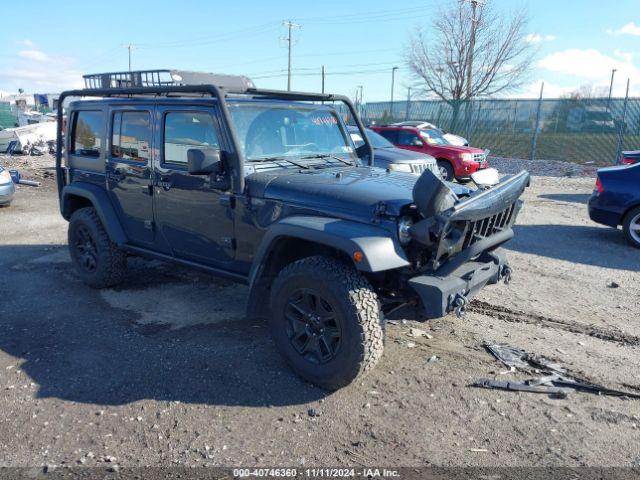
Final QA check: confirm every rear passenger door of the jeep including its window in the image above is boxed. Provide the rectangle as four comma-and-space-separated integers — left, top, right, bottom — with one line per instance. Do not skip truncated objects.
106, 106, 154, 246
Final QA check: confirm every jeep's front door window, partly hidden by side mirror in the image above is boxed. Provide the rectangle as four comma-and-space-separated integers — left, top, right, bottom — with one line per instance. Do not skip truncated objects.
164, 112, 220, 165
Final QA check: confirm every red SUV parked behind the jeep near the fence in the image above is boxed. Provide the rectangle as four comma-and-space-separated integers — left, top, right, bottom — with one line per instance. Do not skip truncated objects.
371, 126, 489, 181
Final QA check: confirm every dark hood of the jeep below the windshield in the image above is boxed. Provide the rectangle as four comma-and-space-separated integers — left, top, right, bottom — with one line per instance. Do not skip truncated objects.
246, 166, 471, 222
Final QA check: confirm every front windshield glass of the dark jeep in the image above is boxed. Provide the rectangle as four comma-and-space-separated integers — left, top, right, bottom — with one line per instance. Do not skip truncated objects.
229, 102, 357, 161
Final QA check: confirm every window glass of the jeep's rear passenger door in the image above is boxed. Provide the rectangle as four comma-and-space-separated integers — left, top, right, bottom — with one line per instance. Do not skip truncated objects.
111, 112, 151, 162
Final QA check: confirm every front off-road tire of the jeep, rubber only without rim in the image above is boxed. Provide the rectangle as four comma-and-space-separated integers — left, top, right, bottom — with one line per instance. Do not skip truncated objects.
270, 256, 384, 390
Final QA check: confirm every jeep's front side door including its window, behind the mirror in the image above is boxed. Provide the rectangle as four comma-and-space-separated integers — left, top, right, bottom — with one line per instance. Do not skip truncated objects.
154, 106, 235, 266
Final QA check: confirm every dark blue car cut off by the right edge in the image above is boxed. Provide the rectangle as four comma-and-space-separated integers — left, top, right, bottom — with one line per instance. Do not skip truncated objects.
589, 163, 640, 248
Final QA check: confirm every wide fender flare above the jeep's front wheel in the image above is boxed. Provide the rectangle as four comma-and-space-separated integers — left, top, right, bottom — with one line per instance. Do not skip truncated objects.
249, 215, 410, 285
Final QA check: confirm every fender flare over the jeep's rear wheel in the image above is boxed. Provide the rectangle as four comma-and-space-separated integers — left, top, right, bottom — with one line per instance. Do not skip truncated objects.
60, 182, 127, 246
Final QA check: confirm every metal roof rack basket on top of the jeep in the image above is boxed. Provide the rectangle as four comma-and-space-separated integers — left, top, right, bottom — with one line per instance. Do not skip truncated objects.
82, 69, 255, 90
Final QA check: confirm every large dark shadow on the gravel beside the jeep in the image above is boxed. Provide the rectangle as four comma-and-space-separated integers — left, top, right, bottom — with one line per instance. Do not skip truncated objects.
0, 245, 327, 407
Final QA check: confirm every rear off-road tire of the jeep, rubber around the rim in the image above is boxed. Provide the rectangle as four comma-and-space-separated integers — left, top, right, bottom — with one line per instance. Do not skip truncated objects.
68, 207, 127, 288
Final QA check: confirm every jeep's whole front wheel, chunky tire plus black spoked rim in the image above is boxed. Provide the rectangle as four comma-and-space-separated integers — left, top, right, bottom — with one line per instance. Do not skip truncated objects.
271, 257, 383, 390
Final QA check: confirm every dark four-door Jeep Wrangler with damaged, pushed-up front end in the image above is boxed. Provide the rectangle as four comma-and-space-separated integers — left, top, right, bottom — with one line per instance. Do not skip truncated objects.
56, 70, 529, 389
